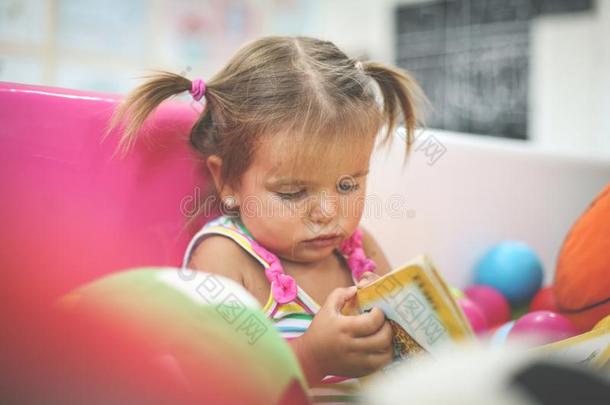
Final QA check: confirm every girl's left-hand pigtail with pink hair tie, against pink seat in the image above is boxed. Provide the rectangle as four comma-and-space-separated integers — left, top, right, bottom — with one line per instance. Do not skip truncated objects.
103, 71, 192, 157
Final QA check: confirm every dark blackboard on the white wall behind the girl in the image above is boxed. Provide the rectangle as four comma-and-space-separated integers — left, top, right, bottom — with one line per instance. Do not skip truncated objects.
395, 0, 592, 139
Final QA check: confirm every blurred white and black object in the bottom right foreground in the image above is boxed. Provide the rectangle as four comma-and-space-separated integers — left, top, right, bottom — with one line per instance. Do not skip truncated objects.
366, 346, 610, 405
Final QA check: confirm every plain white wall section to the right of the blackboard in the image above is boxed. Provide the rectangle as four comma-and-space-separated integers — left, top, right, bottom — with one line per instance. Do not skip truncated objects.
530, 1, 610, 158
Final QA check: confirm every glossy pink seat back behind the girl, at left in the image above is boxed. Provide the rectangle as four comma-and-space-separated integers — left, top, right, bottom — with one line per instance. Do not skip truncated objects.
0, 82, 213, 298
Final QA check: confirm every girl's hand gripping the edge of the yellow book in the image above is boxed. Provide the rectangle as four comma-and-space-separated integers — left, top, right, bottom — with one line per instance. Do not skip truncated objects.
297, 287, 393, 384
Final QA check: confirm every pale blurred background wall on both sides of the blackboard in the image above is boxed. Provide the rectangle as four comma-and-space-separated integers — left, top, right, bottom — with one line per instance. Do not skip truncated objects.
0, 0, 610, 159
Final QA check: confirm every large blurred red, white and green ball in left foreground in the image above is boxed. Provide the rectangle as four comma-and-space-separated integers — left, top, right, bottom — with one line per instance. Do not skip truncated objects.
0, 268, 308, 405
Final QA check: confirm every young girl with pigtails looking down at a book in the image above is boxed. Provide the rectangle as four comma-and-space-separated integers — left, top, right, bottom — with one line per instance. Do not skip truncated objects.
114, 37, 421, 400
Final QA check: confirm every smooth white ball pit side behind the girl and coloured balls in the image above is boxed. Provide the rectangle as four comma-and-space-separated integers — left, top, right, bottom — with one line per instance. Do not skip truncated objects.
363, 131, 610, 287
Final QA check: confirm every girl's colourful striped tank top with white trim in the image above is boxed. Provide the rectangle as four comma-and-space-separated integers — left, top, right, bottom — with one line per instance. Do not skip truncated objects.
182, 216, 371, 404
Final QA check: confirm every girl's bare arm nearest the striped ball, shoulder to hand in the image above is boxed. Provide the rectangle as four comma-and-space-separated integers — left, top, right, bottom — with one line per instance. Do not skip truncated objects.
188, 235, 392, 386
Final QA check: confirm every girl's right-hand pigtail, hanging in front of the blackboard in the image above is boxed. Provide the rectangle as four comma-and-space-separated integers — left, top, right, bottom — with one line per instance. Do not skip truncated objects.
362, 62, 427, 155
